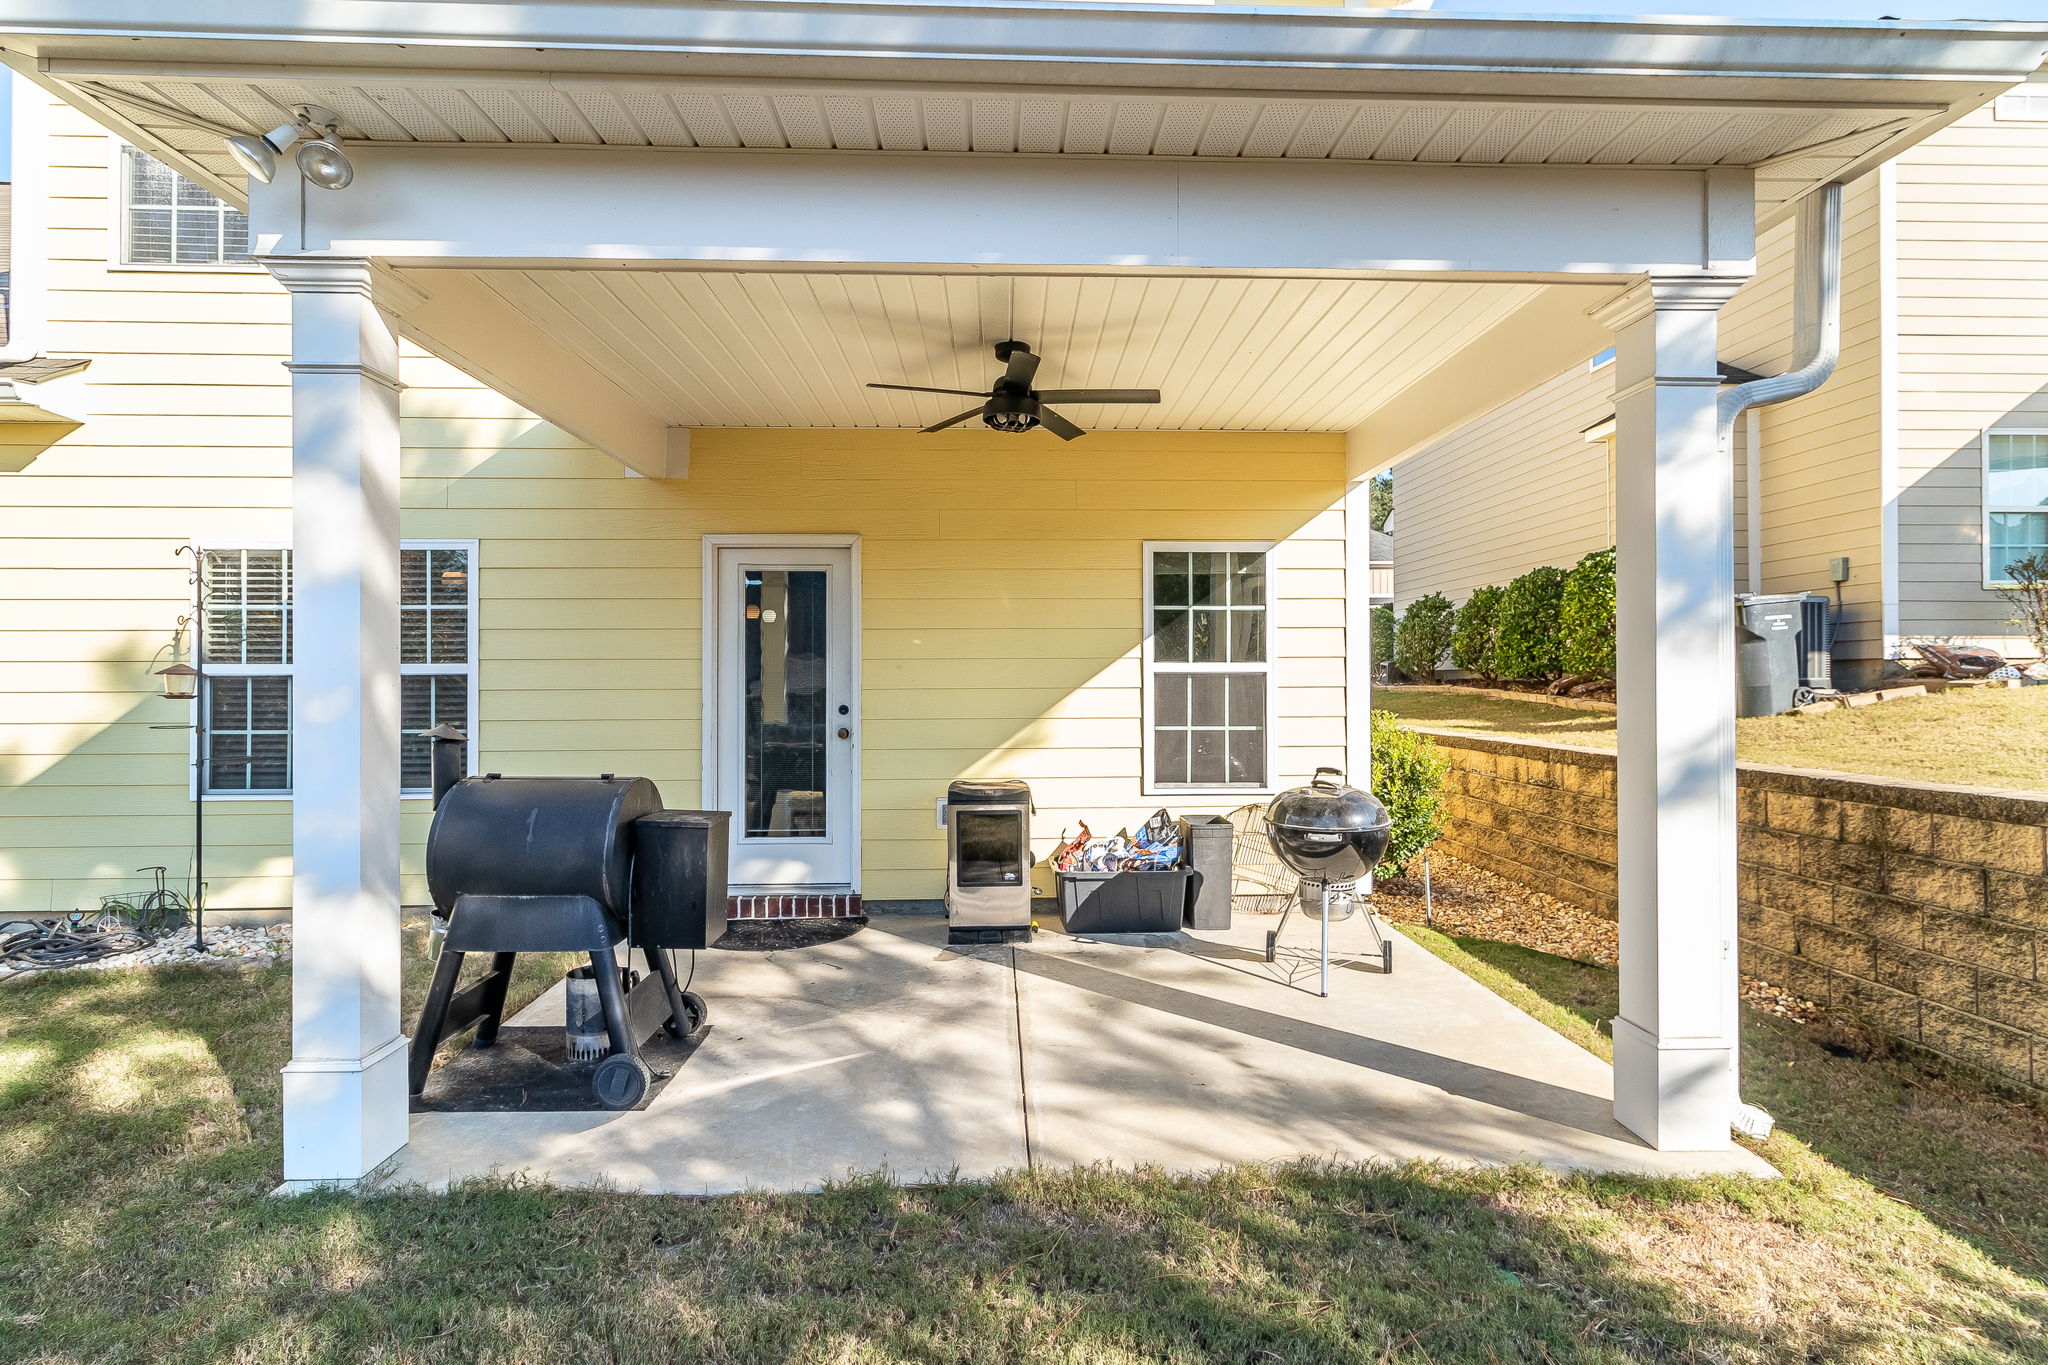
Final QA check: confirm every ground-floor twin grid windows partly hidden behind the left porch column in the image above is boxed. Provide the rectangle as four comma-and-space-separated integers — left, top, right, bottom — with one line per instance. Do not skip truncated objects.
203, 542, 475, 796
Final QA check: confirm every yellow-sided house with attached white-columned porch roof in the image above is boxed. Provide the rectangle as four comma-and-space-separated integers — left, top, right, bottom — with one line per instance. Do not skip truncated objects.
0, 0, 2048, 1187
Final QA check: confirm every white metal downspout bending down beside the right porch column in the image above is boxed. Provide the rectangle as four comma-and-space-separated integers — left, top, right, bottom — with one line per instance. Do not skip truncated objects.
1716, 184, 1841, 1138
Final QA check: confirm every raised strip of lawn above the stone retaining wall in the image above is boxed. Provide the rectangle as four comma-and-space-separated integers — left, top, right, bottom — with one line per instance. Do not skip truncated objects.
1372, 688, 2048, 790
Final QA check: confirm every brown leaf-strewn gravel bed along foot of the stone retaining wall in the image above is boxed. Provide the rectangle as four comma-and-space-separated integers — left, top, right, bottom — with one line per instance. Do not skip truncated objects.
1372, 853, 1821, 1023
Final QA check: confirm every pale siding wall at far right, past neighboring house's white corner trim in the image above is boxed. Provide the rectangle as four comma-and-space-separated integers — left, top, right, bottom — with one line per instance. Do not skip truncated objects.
1896, 90, 2048, 655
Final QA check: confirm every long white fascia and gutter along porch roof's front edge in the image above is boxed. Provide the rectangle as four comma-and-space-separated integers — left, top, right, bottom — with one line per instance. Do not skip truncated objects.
12, 0, 2048, 104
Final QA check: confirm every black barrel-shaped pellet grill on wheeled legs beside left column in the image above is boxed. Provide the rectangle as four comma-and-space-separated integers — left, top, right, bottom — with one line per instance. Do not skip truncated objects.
410, 726, 729, 1109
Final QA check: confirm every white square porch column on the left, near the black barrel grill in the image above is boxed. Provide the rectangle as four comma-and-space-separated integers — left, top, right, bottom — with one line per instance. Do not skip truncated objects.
264, 258, 408, 1191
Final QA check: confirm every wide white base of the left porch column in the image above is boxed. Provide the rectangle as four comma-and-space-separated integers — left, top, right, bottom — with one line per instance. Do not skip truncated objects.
279, 1036, 412, 1193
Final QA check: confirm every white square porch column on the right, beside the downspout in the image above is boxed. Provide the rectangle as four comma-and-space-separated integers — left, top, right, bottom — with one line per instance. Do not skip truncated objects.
1595, 274, 1743, 1152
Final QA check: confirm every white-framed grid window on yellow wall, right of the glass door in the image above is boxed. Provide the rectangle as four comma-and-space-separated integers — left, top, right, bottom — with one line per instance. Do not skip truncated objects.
1145, 546, 1272, 788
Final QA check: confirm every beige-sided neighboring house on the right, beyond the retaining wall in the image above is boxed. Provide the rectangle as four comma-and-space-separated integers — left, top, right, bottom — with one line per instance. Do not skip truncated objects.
1395, 76, 2048, 681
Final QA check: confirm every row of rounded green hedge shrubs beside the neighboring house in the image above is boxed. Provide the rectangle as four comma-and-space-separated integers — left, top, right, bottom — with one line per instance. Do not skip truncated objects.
1372, 548, 1614, 684
